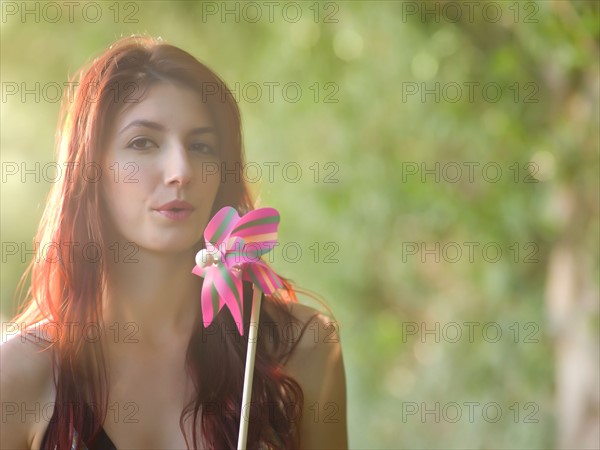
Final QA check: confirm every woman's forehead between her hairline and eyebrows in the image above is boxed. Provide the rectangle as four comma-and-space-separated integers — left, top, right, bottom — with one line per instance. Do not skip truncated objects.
113, 82, 214, 132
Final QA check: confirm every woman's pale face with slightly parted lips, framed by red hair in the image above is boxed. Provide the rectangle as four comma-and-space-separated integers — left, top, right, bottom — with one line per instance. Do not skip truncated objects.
102, 83, 220, 252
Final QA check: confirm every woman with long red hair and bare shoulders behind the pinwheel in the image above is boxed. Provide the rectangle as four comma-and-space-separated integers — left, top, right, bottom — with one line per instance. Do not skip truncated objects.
0, 36, 347, 449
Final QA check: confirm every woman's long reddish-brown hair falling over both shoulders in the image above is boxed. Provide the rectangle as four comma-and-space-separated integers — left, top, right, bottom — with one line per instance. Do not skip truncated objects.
14, 35, 304, 449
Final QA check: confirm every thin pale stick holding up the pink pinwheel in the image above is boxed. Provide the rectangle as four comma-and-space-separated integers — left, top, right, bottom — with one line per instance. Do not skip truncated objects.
237, 286, 262, 450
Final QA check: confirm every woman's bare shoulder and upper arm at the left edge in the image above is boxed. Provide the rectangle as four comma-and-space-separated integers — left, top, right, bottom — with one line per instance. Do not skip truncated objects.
0, 334, 54, 449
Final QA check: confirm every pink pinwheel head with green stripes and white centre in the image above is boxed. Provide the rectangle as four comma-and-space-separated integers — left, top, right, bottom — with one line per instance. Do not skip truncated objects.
192, 206, 283, 335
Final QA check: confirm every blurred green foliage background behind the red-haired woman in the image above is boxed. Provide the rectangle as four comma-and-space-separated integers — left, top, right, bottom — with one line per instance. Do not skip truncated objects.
1, 1, 599, 448
